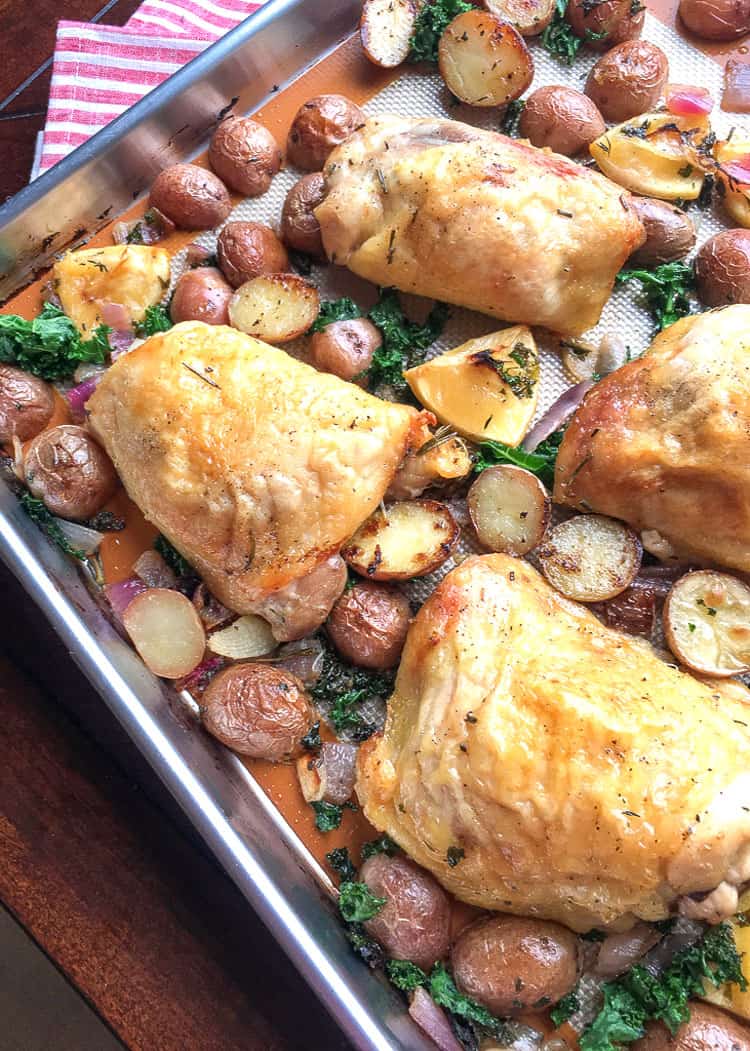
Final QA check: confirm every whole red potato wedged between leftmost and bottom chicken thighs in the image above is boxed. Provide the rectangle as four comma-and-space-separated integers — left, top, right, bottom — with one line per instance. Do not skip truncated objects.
328, 580, 412, 669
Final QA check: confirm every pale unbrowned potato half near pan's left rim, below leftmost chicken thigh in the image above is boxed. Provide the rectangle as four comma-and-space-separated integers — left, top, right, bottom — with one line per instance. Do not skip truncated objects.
122, 588, 206, 679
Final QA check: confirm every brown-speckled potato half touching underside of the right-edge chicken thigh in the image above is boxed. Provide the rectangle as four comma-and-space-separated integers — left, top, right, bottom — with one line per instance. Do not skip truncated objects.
538, 515, 643, 602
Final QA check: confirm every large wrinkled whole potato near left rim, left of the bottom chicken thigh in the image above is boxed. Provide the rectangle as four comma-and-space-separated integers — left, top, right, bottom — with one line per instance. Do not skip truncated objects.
202, 664, 312, 763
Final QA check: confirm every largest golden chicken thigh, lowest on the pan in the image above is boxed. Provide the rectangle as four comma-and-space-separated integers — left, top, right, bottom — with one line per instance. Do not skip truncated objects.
357, 555, 750, 930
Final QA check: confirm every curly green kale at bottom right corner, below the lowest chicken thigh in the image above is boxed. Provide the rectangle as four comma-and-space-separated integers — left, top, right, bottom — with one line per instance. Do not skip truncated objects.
579, 923, 747, 1051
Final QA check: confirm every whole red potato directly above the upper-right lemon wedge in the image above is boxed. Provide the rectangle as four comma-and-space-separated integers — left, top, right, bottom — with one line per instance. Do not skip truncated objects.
585, 40, 669, 124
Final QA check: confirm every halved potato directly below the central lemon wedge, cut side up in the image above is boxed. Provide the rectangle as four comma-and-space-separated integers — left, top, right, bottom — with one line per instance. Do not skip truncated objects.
466, 463, 550, 555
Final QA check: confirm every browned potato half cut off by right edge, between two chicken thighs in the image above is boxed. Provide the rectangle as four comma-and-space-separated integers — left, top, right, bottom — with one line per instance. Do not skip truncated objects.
664, 570, 750, 676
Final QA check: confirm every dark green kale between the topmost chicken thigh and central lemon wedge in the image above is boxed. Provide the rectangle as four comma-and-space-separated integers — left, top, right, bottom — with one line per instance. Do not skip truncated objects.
367, 288, 449, 391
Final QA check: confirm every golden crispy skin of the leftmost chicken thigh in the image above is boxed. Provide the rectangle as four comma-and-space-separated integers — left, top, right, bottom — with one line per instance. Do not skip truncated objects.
87, 322, 431, 616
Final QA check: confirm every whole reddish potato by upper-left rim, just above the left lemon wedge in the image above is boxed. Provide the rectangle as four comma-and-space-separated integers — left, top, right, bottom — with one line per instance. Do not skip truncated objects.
149, 164, 232, 230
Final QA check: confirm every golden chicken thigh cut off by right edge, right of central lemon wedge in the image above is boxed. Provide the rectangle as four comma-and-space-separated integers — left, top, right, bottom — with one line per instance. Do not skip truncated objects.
555, 305, 750, 571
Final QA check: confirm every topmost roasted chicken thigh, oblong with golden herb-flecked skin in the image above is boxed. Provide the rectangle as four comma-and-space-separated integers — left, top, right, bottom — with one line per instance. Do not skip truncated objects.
315, 117, 645, 334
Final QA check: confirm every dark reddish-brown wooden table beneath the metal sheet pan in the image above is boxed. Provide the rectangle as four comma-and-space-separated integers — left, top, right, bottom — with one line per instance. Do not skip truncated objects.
0, 0, 349, 1051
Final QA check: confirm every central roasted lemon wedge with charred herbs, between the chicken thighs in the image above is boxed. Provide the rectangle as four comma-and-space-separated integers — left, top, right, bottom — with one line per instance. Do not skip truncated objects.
403, 325, 539, 446
